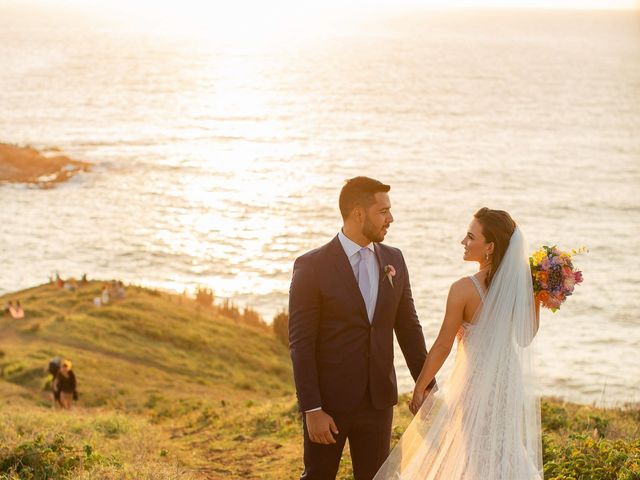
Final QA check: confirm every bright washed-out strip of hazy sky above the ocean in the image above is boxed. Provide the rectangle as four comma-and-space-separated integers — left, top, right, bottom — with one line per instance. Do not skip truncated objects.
7, 0, 640, 41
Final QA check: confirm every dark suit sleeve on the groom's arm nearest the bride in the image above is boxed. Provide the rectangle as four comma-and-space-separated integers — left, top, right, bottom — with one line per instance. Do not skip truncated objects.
394, 253, 435, 388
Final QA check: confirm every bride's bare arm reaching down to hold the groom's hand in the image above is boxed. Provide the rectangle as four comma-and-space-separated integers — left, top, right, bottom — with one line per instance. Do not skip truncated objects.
412, 280, 465, 407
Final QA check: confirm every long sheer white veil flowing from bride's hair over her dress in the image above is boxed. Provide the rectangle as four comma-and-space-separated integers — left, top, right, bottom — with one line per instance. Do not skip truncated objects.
374, 229, 543, 480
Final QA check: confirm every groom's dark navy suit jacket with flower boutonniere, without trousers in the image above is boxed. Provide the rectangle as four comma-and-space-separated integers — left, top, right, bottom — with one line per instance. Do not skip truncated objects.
289, 236, 436, 412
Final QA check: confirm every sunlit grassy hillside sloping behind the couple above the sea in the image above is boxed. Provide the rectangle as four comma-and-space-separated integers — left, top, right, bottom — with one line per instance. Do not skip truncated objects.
0, 282, 640, 480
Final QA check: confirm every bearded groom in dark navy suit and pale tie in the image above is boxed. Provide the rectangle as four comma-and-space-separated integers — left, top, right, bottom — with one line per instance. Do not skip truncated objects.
289, 177, 434, 480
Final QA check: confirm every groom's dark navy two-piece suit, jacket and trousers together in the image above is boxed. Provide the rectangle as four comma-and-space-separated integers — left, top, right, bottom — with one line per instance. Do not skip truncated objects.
289, 236, 436, 480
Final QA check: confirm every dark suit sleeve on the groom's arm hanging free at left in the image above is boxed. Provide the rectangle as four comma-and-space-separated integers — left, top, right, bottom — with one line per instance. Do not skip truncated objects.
289, 257, 322, 412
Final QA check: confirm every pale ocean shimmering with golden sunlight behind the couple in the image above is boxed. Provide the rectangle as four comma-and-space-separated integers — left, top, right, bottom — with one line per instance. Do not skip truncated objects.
0, 6, 640, 406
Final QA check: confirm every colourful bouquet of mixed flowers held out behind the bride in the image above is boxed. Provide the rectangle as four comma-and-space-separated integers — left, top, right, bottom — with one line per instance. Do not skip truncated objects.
529, 245, 587, 312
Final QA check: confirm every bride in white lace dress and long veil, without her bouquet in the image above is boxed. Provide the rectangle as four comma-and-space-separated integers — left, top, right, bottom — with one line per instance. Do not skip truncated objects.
374, 208, 543, 480
